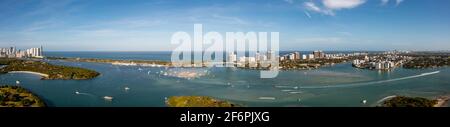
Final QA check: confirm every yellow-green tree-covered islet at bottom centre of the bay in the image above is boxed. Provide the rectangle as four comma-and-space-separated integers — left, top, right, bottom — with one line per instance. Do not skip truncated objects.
166, 96, 239, 107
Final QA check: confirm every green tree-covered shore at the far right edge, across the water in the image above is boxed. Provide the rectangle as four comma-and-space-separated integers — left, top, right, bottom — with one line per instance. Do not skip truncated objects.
403, 56, 450, 69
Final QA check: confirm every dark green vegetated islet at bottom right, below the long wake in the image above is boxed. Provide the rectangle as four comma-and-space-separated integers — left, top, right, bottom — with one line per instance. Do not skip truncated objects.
382, 96, 438, 107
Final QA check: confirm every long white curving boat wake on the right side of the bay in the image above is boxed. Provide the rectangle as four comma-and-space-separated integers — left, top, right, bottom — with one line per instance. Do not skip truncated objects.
300, 71, 440, 89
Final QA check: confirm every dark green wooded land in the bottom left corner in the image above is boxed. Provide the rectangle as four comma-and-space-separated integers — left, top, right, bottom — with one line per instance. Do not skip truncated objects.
0, 85, 46, 107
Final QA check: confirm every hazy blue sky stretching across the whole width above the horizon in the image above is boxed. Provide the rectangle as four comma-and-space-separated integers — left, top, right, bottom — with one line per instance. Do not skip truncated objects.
0, 0, 450, 51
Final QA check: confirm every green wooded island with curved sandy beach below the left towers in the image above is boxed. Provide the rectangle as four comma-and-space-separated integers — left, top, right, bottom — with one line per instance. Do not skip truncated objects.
0, 59, 100, 80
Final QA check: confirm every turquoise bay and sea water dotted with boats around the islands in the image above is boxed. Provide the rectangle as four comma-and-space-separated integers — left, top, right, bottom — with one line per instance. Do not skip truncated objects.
0, 52, 450, 107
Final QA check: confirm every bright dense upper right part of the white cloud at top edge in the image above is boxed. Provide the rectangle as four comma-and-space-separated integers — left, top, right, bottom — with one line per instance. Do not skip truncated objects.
322, 0, 366, 10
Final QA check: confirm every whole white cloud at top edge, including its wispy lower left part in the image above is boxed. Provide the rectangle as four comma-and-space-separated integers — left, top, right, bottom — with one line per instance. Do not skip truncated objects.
303, 0, 366, 16
